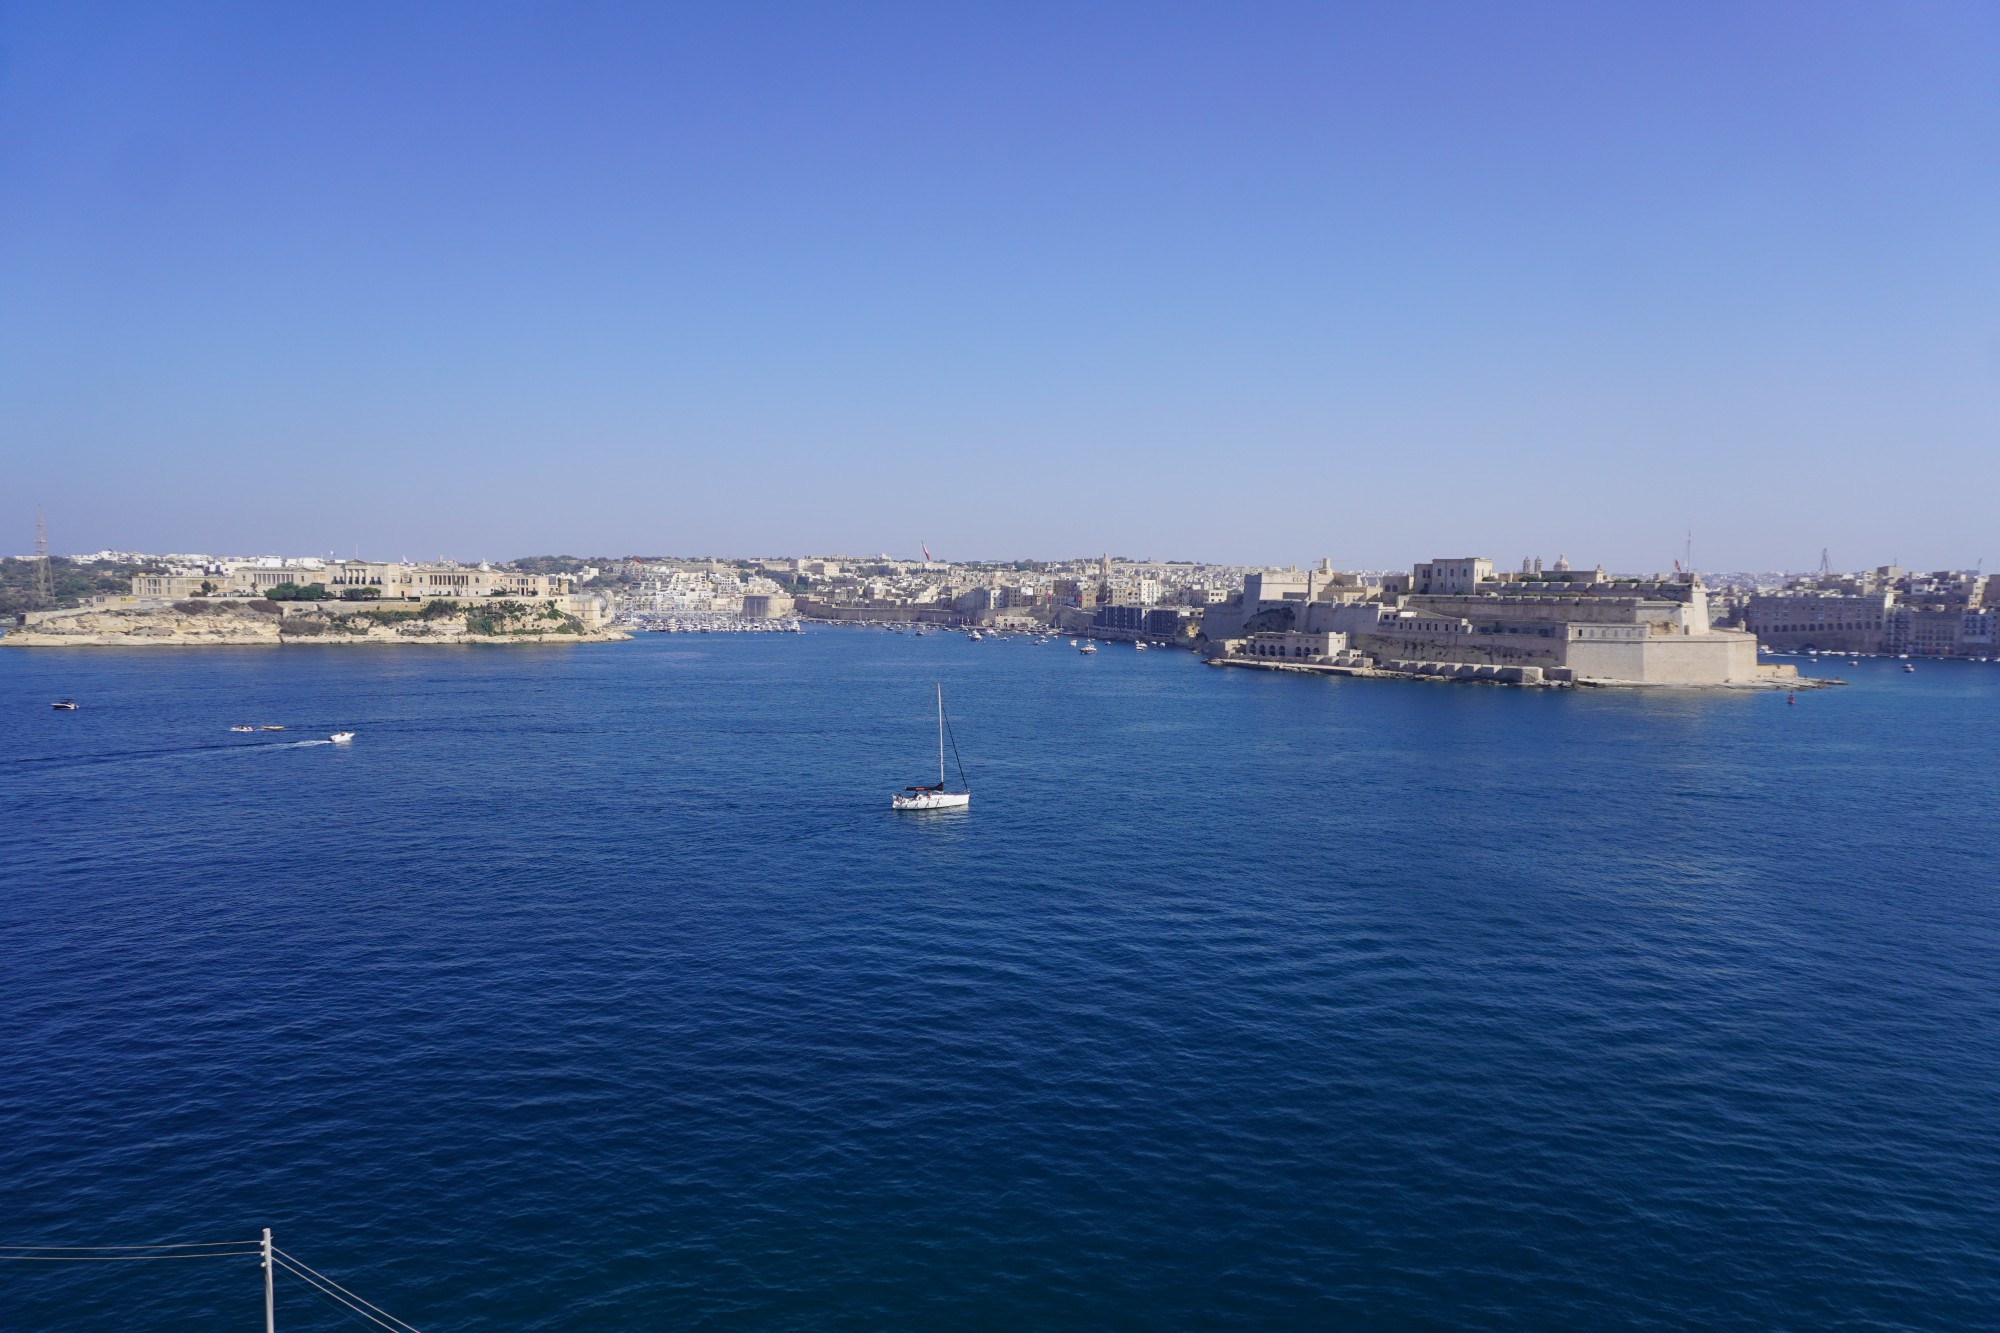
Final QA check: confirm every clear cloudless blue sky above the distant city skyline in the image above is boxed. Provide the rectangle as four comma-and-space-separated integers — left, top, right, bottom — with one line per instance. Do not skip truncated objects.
0, 0, 2000, 568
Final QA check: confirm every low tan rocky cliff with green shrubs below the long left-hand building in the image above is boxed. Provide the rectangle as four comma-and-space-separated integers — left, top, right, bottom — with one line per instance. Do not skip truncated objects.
0, 600, 630, 648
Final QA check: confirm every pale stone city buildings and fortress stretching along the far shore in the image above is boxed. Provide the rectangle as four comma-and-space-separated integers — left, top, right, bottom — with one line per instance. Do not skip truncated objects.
6, 550, 2000, 685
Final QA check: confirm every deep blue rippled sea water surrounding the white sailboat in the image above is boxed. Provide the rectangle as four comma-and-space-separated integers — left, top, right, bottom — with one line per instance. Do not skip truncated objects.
0, 628, 2000, 1333
